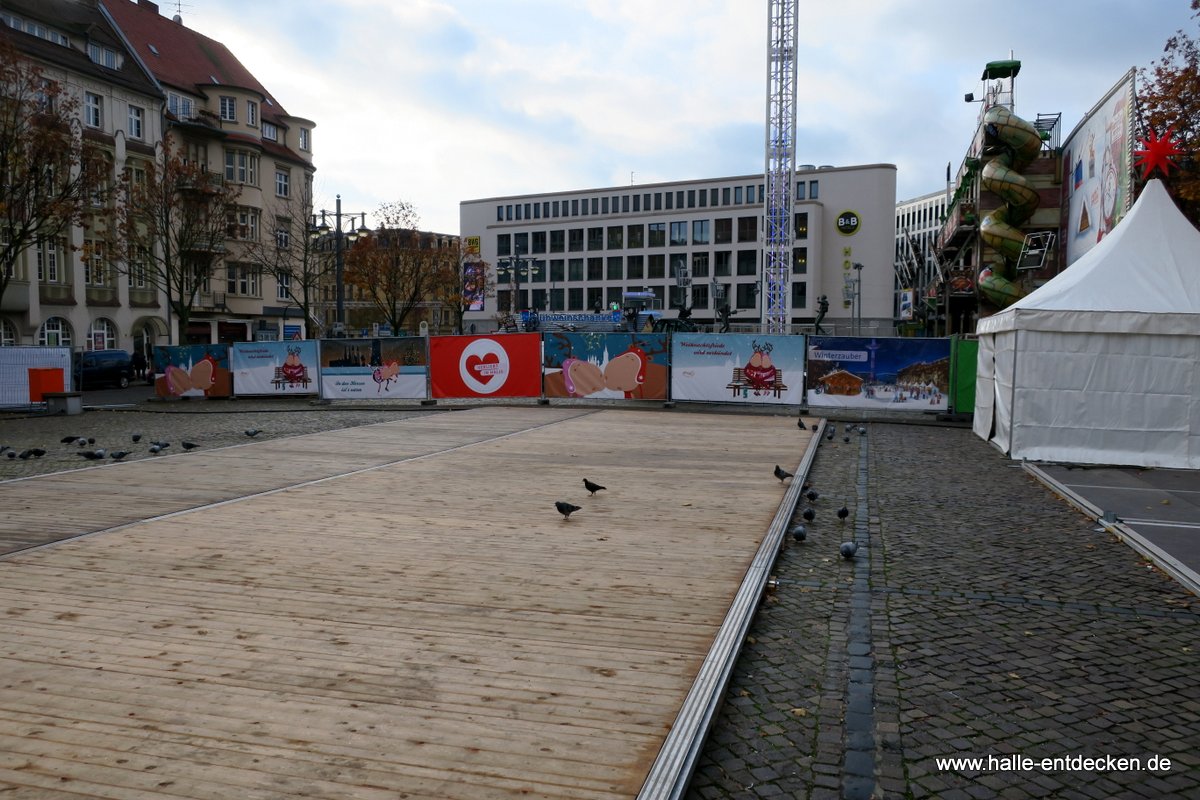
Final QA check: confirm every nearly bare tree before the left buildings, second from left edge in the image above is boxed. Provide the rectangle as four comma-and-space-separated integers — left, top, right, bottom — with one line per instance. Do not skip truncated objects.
115, 155, 240, 341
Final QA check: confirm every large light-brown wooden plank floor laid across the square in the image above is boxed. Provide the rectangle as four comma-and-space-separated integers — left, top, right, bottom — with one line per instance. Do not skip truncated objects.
0, 408, 811, 800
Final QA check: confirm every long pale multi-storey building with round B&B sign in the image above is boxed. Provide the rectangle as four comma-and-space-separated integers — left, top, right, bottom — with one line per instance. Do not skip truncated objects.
460, 164, 895, 335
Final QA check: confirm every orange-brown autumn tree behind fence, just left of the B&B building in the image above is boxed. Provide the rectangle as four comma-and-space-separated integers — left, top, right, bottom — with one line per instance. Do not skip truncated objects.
344, 200, 458, 332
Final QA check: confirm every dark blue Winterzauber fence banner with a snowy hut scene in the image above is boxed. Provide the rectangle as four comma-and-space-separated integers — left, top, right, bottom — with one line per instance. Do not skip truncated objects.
806, 336, 950, 411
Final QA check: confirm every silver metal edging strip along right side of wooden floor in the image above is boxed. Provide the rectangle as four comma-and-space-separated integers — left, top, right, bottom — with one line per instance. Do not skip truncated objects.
637, 420, 827, 800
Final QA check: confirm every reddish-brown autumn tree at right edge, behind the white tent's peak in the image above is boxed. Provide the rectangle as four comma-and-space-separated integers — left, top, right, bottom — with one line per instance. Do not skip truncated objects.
1138, 0, 1200, 224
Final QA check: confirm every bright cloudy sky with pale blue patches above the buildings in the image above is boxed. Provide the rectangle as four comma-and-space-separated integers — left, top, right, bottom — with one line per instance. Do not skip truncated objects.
174, 0, 1200, 233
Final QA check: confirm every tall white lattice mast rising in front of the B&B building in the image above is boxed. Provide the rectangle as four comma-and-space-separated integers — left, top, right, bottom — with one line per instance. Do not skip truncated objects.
761, 0, 799, 333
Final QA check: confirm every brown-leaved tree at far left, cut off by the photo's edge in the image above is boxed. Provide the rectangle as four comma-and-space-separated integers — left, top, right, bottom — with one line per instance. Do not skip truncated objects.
0, 40, 112, 309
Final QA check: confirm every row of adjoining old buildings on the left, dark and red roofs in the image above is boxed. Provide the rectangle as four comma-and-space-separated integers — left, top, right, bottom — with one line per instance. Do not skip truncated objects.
0, 0, 314, 353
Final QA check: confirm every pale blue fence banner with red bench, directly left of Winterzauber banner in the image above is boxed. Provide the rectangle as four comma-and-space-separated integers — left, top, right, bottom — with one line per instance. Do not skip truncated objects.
671, 333, 805, 405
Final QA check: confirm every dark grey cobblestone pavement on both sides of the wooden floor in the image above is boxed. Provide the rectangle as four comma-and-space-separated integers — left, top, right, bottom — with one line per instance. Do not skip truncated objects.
0, 399, 1200, 800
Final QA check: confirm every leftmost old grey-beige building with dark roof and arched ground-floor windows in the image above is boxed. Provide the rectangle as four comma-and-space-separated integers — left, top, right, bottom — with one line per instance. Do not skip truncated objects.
0, 0, 167, 349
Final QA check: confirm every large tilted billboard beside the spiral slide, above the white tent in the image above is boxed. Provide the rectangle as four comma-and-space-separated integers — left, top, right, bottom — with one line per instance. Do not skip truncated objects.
1062, 70, 1134, 266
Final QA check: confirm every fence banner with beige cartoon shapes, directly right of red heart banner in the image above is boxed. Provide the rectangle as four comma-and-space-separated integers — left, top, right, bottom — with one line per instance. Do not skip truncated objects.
542, 332, 671, 399
